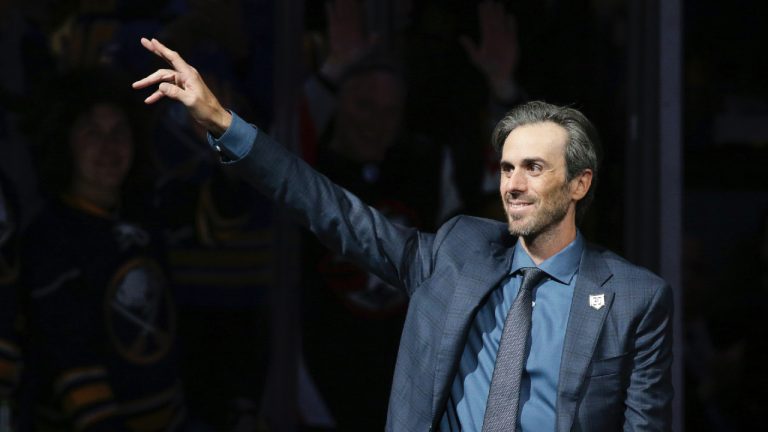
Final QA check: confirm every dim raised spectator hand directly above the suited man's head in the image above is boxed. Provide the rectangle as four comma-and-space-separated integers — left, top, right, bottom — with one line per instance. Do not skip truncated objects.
459, 0, 520, 101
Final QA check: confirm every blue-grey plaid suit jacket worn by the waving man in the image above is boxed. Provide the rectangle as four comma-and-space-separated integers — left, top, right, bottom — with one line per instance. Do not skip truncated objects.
228, 127, 672, 432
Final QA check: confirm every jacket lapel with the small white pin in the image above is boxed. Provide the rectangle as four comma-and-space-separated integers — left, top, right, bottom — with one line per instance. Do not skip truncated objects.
557, 246, 614, 431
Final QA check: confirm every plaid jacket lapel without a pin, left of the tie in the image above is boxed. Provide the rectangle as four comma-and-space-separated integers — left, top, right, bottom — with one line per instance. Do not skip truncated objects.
432, 242, 514, 415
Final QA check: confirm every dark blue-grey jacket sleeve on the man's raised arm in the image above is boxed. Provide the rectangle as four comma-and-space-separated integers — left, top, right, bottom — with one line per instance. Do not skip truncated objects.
219, 117, 434, 294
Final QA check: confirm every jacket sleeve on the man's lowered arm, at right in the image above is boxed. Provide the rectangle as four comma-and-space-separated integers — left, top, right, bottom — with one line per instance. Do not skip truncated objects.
624, 284, 673, 431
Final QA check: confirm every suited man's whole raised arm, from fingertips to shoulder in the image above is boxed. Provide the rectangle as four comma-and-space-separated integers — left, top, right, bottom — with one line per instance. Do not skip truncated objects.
134, 39, 434, 293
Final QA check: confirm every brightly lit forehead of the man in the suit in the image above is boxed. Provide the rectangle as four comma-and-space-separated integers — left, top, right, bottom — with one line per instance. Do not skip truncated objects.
501, 122, 568, 162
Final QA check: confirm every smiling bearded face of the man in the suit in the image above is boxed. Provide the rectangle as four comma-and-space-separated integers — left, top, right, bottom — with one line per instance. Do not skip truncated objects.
499, 122, 580, 237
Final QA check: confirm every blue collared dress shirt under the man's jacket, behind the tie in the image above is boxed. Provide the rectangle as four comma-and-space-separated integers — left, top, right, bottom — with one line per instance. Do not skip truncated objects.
440, 233, 584, 432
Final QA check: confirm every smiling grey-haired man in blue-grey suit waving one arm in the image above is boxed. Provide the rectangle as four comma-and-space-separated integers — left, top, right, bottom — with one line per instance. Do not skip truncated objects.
134, 39, 672, 432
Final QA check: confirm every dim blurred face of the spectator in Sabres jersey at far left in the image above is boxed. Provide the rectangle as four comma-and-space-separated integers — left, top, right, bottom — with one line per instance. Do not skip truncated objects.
69, 104, 134, 194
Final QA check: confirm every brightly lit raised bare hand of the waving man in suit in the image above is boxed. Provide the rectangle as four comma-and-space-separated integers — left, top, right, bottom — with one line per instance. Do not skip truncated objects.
133, 38, 232, 136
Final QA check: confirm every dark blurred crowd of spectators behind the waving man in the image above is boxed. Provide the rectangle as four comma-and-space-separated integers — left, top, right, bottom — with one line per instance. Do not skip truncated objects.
0, 0, 768, 432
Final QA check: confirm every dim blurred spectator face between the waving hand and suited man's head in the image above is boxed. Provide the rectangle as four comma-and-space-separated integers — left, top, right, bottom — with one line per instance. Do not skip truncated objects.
333, 71, 404, 162
